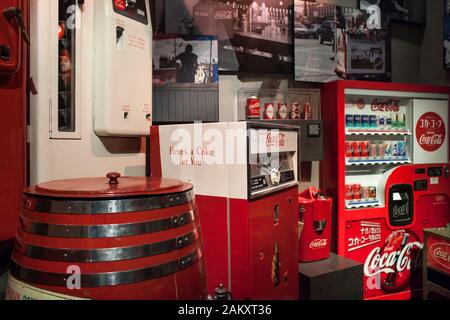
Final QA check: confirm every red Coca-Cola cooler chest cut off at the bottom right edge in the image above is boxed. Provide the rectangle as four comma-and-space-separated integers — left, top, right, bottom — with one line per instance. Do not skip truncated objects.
423, 224, 450, 300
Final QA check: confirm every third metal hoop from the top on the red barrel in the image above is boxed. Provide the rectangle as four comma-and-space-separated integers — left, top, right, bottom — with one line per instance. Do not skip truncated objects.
16, 230, 199, 263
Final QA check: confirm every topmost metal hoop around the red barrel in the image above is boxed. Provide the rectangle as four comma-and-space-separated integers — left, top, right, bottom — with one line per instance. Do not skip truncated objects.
23, 190, 195, 214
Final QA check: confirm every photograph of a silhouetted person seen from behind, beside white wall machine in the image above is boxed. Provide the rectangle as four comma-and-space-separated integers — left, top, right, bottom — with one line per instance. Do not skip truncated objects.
153, 34, 219, 86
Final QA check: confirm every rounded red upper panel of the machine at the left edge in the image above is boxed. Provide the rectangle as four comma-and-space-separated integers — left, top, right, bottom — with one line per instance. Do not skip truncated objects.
0, 0, 26, 74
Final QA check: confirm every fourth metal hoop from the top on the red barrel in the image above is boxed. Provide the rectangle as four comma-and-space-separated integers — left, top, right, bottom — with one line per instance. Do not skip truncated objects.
10, 248, 203, 288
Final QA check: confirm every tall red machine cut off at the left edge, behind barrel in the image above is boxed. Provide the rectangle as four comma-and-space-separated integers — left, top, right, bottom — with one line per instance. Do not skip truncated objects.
0, 0, 29, 244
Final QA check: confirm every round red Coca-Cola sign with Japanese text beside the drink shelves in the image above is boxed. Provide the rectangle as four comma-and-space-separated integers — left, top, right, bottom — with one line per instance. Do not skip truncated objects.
416, 112, 446, 152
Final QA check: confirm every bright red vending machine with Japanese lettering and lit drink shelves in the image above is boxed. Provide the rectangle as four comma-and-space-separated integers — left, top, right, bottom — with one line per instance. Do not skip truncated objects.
321, 81, 450, 299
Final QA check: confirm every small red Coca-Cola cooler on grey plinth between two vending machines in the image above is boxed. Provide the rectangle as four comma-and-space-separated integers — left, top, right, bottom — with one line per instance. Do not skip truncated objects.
298, 188, 333, 262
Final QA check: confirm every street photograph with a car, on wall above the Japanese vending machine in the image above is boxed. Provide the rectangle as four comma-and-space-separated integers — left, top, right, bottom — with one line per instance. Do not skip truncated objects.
294, 0, 390, 82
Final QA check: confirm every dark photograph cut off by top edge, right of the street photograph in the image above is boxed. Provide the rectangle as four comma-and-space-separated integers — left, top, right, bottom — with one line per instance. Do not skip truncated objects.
359, 0, 427, 24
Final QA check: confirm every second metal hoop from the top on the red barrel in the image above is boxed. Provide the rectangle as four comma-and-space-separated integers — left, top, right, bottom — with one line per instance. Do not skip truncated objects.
20, 210, 197, 239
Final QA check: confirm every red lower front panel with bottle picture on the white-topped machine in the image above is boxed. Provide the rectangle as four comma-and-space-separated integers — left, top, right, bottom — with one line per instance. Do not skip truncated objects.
249, 187, 298, 300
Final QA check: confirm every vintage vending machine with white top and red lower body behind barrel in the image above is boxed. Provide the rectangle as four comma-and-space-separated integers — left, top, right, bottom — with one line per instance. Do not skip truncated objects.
148, 122, 299, 300
